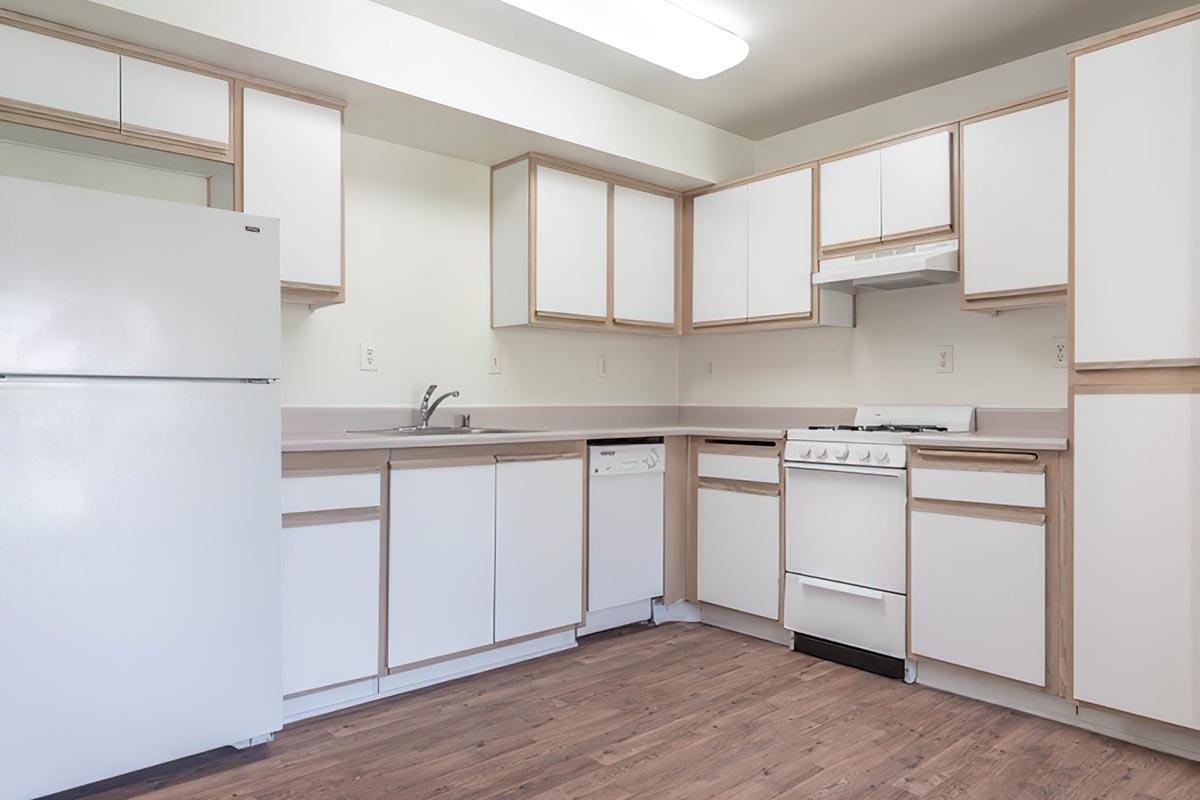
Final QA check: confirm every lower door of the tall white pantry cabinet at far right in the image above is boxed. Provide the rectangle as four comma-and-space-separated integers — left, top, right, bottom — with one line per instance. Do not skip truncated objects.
1072, 393, 1200, 729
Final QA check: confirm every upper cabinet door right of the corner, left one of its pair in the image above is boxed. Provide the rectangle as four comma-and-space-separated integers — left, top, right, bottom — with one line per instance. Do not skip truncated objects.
691, 186, 750, 325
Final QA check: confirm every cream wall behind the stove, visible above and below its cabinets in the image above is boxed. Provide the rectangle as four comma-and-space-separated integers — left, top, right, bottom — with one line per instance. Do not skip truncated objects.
679, 50, 1067, 408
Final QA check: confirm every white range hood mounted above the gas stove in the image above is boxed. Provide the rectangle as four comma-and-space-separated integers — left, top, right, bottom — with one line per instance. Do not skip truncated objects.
812, 239, 959, 294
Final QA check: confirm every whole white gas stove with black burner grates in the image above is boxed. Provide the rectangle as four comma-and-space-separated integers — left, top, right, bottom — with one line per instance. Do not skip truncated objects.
784, 405, 974, 678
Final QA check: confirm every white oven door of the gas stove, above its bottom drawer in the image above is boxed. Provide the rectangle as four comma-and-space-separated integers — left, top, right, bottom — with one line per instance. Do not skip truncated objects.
786, 463, 908, 595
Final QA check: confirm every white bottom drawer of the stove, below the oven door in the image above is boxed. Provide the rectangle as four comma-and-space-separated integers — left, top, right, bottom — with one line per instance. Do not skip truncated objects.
784, 572, 905, 658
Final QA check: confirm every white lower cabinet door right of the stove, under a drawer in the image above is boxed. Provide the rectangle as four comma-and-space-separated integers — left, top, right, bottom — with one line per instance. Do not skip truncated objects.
908, 511, 1046, 686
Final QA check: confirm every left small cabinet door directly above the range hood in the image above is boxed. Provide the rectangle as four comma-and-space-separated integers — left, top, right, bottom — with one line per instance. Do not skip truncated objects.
820, 150, 881, 247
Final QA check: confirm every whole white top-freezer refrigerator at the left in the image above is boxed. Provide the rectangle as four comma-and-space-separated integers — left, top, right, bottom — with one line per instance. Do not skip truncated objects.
0, 178, 282, 800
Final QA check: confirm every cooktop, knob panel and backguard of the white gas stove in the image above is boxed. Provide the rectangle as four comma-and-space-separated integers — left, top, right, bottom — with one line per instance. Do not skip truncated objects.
784, 405, 974, 469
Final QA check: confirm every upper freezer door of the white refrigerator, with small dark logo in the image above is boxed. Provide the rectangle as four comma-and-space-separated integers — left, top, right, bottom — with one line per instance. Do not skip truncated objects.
0, 176, 280, 378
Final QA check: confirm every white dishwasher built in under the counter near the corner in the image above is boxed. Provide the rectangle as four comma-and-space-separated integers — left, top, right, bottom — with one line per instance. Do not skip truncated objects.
577, 443, 666, 636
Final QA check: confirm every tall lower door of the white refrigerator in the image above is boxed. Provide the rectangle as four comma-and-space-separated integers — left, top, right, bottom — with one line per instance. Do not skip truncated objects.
0, 378, 282, 800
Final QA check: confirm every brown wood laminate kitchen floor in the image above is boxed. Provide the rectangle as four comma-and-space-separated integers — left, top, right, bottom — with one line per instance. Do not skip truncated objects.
55, 624, 1200, 800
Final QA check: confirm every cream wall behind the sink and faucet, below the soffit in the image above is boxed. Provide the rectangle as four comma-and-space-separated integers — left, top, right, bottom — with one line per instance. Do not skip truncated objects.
282, 134, 678, 405
